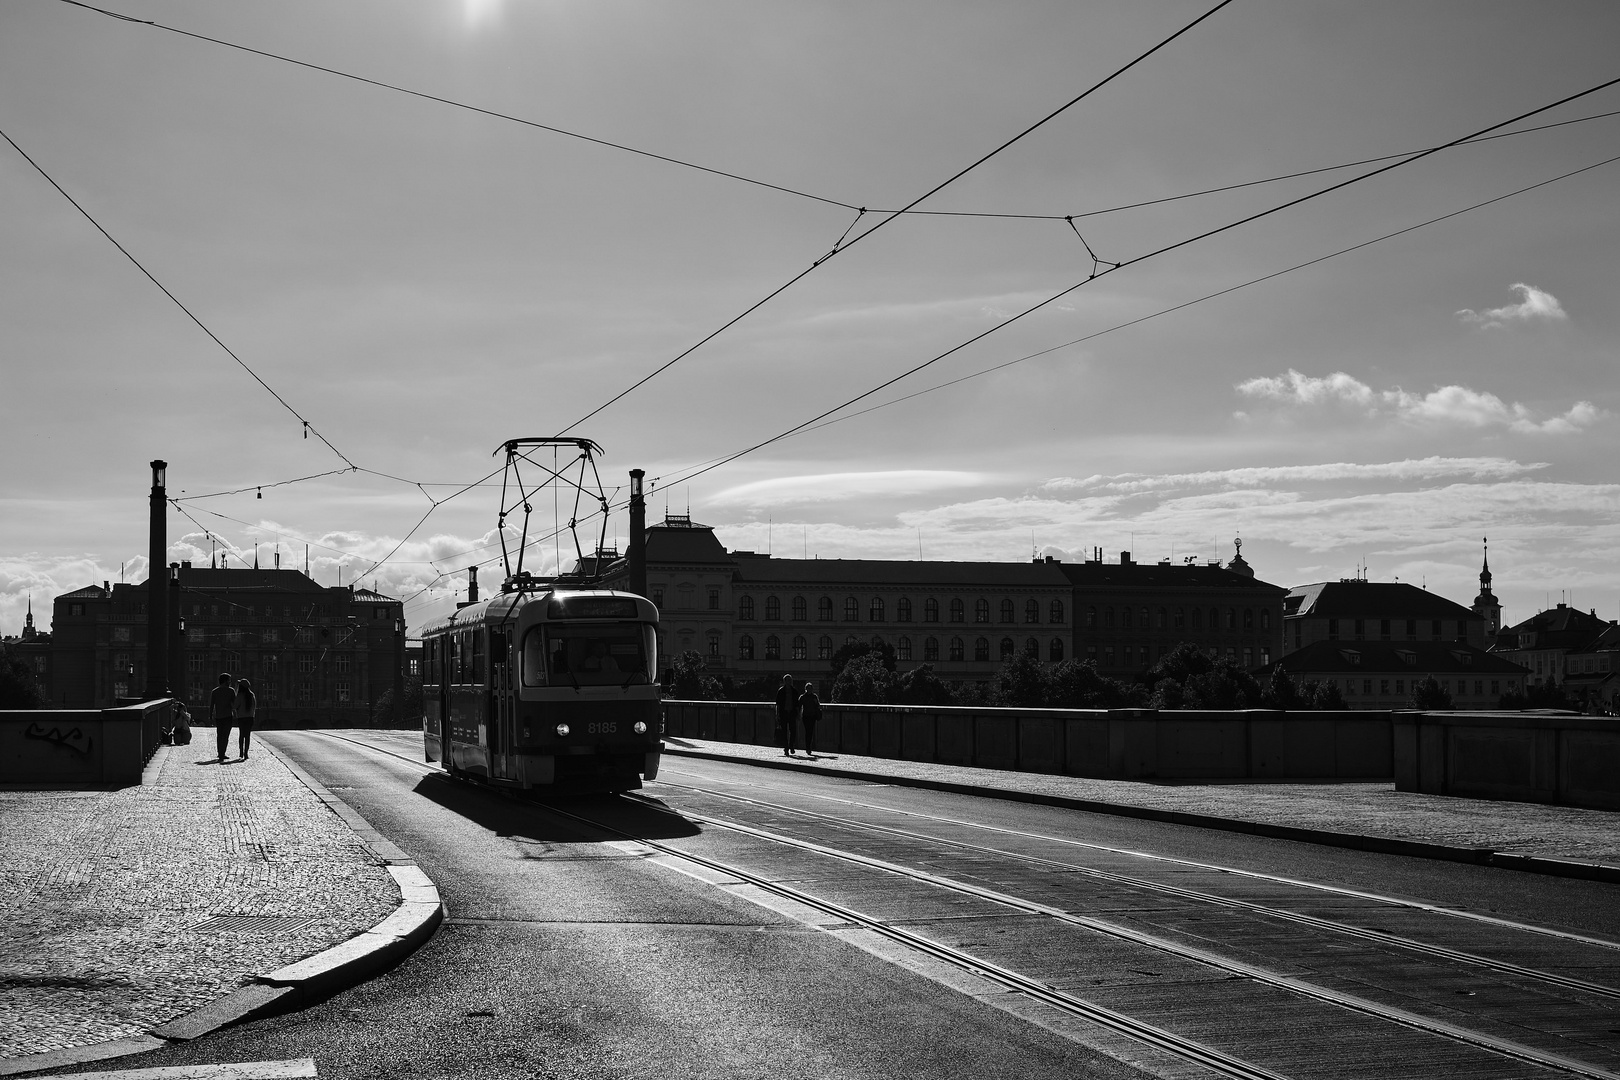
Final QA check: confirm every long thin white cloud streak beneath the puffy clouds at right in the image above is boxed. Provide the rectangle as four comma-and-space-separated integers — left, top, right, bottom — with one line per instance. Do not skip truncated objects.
1042, 457, 1547, 495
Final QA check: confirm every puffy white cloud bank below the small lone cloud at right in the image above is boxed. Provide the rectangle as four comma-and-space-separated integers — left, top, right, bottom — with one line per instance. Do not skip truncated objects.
1236, 368, 1609, 436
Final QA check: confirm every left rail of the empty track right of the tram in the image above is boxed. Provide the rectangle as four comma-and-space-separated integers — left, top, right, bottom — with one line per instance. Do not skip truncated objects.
654, 780, 1620, 999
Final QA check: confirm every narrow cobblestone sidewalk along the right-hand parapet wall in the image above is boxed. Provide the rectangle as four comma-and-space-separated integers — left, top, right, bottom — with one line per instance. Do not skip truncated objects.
666, 738, 1620, 866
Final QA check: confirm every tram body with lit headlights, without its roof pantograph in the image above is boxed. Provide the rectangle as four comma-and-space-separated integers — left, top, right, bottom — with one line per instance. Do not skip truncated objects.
423, 575, 663, 792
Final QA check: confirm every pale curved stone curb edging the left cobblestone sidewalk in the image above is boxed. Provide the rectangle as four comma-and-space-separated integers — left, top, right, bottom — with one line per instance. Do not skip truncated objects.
0, 742, 444, 1077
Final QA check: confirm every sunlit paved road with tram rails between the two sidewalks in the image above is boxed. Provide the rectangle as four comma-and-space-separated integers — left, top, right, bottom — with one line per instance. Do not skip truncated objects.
38, 732, 1620, 1078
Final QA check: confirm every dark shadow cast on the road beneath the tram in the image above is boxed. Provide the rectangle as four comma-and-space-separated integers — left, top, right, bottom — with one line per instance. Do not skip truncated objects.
413, 772, 701, 844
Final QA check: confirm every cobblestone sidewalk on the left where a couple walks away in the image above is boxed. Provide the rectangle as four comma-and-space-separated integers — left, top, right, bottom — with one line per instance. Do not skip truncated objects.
0, 738, 400, 1057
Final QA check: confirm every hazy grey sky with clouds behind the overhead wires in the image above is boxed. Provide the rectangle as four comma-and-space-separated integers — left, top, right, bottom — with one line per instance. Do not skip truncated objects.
0, 0, 1620, 633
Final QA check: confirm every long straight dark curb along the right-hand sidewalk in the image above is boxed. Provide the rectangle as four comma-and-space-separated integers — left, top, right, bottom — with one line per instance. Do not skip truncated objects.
664, 740, 1620, 884
